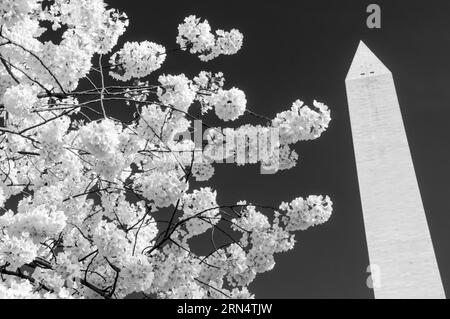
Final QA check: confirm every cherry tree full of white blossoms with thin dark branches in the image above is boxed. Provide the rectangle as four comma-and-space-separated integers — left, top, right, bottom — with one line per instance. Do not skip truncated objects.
0, 0, 332, 299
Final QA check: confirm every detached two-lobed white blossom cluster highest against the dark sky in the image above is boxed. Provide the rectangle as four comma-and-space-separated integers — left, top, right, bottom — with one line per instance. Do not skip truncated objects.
177, 15, 243, 61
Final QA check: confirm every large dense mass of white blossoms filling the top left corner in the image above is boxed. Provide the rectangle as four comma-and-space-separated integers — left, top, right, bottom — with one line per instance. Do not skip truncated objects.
0, 0, 128, 92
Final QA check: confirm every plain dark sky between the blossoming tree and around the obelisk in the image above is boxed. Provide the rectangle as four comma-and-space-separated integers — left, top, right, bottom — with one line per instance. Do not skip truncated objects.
102, 0, 450, 298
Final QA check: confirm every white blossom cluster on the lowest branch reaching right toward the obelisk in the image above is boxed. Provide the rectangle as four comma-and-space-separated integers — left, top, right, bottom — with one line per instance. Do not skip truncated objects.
194, 196, 332, 298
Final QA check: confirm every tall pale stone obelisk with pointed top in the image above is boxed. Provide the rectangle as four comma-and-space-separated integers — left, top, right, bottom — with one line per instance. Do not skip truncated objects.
345, 41, 445, 299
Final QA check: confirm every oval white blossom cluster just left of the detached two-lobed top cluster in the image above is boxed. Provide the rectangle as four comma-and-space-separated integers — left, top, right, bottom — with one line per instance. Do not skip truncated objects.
109, 41, 166, 81
